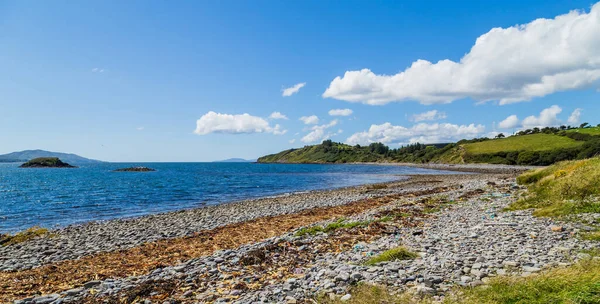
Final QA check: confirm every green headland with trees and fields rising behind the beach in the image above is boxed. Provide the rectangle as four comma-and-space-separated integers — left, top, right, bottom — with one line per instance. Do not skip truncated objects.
258, 126, 600, 165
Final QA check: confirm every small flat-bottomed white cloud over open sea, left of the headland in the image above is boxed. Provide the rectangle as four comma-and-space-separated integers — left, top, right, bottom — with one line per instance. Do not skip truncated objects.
194, 111, 287, 135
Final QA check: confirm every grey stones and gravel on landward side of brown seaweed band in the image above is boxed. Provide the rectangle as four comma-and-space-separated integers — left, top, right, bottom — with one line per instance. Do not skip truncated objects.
23, 169, 599, 303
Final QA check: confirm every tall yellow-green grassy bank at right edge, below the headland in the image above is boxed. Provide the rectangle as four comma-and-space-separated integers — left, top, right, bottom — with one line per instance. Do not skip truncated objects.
509, 157, 600, 216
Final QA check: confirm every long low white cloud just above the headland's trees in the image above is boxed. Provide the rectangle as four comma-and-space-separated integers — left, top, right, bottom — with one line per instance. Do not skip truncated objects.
346, 122, 485, 145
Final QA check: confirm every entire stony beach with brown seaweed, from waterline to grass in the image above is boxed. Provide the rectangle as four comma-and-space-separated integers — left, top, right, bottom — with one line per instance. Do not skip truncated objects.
0, 167, 599, 303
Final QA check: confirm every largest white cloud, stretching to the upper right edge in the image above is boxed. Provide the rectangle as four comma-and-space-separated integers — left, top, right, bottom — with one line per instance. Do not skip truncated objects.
323, 3, 600, 105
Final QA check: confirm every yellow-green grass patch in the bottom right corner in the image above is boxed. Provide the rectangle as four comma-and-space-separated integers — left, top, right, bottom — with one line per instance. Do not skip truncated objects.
447, 260, 600, 304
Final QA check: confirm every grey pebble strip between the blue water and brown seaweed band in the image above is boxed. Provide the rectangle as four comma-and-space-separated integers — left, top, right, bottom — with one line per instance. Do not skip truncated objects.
0, 174, 469, 272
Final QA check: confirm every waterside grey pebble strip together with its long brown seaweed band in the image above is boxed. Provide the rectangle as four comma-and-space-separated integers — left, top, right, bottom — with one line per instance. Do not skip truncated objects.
0, 168, 540, 300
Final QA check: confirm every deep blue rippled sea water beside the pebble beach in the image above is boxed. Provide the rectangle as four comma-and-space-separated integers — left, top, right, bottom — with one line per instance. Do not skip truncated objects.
0, 163, 452, 233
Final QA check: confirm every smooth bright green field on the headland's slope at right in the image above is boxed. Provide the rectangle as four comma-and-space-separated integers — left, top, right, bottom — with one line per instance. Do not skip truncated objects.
464, 133, 583, 154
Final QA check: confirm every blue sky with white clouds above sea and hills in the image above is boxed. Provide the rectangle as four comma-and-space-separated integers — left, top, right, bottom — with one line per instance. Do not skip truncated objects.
0, 0, 600, 161
